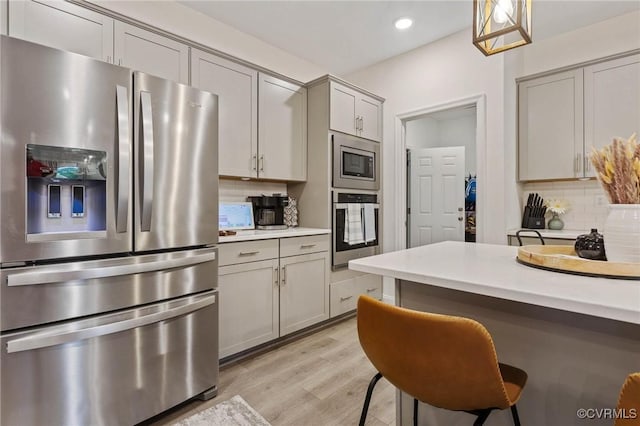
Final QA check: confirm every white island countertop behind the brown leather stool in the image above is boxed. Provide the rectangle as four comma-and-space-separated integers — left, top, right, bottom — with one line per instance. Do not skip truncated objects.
349, 241, 640, 324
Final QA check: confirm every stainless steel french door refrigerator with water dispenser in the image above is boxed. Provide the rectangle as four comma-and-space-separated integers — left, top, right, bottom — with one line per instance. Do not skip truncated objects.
0, 36, 218, 426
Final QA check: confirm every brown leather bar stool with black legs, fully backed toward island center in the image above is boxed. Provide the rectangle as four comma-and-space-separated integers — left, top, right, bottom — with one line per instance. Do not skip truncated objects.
357, 295, 527, 426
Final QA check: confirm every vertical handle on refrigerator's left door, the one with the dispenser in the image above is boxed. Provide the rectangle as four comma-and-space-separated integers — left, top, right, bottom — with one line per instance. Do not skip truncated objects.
116, 86, 130, 233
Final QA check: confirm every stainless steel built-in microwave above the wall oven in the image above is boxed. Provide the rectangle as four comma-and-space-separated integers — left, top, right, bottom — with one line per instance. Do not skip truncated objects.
331, 133, 380, 191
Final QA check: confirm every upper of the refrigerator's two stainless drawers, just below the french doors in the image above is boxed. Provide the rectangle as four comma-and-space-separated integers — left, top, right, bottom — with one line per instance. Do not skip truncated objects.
0, 248, 218, 332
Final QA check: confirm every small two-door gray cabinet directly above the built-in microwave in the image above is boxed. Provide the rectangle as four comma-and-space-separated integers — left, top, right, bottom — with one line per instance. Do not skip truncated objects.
329, 81, 382, 142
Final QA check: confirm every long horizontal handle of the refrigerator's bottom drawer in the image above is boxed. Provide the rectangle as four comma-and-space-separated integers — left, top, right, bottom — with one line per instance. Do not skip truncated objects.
7, 294, 216, 353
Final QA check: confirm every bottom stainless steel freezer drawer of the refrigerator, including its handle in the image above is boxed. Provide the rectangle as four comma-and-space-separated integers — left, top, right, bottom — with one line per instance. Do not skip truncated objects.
0, 291, 218, 426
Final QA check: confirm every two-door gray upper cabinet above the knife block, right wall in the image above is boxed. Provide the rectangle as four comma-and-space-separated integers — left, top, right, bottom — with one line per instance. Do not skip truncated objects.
518, 50, 640, 181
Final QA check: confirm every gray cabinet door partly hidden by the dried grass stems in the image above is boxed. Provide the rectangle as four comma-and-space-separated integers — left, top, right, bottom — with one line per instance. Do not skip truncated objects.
584, 54, 640, 176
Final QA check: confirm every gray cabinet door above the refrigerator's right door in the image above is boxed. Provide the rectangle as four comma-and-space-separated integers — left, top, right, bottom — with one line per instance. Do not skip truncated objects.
114, 21, 189, 84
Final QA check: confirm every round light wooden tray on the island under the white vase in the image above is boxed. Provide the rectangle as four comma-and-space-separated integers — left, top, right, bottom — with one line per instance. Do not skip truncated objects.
516, 245, 640, 280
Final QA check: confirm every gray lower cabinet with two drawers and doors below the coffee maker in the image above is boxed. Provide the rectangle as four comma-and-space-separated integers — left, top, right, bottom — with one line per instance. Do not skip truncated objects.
218, 235, 330, 358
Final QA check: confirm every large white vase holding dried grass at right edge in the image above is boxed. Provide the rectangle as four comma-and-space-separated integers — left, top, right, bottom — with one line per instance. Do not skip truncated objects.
602, 204, 640, 263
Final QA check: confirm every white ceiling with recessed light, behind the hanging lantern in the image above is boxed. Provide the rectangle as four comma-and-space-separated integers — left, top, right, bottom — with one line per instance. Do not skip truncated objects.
179, 0, 640, 75
